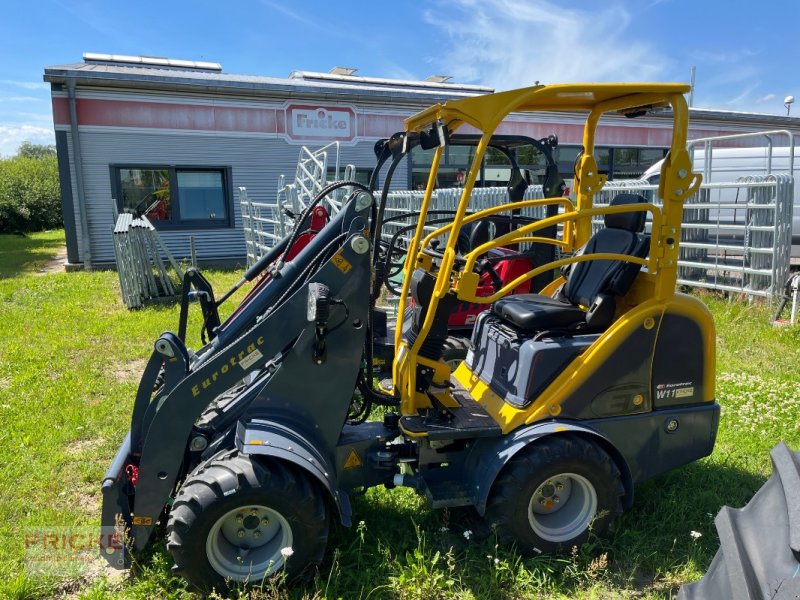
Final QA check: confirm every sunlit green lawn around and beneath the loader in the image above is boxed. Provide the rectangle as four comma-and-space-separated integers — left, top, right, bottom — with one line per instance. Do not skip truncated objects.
0, 233, 800, 599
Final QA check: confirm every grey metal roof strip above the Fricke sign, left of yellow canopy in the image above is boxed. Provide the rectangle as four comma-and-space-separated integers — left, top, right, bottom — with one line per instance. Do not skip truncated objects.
44, 62, 492, 102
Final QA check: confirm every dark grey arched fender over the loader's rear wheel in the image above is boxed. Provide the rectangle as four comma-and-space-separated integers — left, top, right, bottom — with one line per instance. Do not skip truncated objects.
468, 420, 633, 515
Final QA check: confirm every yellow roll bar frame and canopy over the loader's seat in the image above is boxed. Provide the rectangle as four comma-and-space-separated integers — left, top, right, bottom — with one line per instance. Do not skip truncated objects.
393, 83, 700, 414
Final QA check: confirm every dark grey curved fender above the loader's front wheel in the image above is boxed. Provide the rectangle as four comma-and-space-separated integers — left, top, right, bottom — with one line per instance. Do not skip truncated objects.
236, 419, 352, 527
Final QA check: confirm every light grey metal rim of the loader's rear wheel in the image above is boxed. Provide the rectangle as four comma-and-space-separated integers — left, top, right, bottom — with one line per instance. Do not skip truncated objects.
528, 473, 597, 542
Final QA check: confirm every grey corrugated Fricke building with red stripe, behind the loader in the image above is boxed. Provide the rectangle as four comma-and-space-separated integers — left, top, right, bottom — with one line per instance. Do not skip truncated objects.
44, 55, 796, 267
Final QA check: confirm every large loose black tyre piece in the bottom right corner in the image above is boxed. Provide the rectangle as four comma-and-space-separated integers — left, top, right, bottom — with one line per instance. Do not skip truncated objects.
678, 442, 800, 600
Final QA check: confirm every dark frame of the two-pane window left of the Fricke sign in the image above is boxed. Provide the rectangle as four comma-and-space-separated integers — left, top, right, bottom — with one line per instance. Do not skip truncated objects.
109, 163, 235, 231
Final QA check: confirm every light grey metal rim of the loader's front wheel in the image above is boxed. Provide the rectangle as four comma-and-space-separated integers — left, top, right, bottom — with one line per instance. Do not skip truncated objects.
206, 505, 293, 581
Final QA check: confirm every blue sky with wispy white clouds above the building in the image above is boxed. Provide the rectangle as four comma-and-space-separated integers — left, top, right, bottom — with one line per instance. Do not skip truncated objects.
0, 0, 800, 155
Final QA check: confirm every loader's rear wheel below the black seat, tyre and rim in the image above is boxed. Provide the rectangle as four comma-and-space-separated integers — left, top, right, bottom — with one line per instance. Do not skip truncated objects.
486, 435, 625, 556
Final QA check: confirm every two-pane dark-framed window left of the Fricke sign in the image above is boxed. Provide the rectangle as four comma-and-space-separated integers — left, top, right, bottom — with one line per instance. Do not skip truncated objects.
111, 166, 233, 229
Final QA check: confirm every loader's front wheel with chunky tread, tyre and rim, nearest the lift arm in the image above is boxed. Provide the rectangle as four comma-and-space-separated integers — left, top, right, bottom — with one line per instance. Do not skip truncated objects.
167, 450, 329, 592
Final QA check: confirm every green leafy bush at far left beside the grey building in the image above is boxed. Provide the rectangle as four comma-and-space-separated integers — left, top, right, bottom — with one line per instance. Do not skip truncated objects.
0, 149, 64, 233
